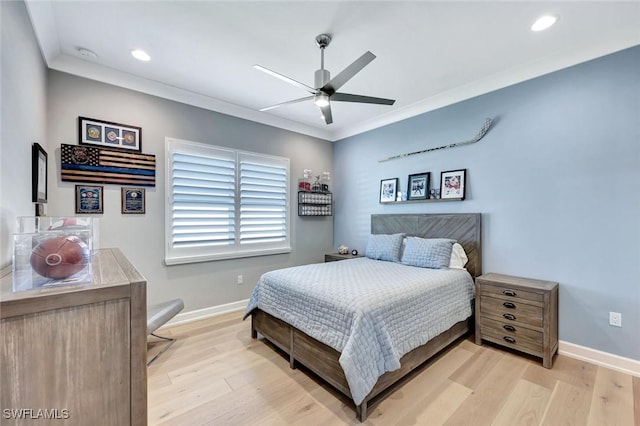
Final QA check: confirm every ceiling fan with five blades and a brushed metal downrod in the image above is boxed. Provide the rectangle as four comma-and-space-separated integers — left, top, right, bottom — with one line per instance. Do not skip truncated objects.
253, 34, 395, 124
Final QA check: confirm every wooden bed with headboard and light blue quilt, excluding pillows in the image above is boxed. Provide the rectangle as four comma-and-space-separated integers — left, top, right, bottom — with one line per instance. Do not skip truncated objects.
245, 213, 481, 421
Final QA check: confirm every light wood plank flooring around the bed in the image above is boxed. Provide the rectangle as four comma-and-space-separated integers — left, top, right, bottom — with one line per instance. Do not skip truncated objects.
148, 313, 640, 426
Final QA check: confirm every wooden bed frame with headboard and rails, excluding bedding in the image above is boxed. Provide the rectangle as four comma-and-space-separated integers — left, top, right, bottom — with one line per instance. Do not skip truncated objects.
251, 213, 482, 422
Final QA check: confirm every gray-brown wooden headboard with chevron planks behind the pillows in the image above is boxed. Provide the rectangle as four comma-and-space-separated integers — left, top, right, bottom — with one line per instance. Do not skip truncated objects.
371, 213, 482, 278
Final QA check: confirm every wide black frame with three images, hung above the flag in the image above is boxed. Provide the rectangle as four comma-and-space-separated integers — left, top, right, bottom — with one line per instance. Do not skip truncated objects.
78, 117, 142, 152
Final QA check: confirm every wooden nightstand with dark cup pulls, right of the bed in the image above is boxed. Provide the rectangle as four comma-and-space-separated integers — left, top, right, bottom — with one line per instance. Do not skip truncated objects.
476, 274, 558, 368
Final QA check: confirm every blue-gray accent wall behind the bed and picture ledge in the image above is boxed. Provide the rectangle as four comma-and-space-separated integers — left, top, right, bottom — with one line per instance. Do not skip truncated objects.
334, 47, 640, 360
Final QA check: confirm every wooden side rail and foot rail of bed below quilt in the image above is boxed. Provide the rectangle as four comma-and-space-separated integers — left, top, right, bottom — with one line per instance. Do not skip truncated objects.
251, 309, 473, 422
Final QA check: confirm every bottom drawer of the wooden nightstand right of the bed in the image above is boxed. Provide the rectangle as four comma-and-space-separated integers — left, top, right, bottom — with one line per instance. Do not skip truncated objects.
480, 317, 543, 356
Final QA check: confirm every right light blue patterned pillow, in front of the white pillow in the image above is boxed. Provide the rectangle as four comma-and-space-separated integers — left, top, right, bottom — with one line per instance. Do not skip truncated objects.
402, 237, 456, 269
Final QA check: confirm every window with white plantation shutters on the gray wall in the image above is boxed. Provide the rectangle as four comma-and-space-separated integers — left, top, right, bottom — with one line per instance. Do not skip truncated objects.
165, 138, 291, 265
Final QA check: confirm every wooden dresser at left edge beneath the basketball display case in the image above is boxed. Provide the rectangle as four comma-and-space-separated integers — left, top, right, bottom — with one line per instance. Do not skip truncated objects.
0, 249, 147, 426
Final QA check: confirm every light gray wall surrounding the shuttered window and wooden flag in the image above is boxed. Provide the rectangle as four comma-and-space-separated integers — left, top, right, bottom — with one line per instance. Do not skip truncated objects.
48, 71, 333, 311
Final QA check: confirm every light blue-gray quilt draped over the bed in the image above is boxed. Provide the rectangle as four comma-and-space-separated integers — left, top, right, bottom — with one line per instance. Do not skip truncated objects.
245, 258, 474, 405
